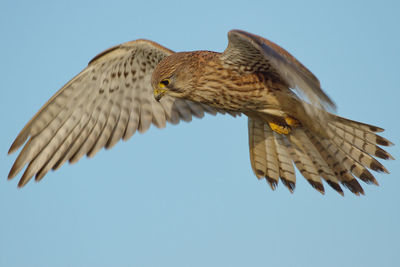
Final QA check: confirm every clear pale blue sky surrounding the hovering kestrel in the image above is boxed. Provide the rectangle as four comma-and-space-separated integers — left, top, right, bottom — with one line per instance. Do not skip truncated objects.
0, 0, 400, 267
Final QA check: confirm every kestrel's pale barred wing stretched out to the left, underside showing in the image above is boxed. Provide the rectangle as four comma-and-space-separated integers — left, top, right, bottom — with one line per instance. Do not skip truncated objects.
8, 40, 216, 187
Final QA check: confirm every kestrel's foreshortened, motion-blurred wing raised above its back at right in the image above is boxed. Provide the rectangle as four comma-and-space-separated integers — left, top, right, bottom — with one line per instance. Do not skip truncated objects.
222, 30, 335, 119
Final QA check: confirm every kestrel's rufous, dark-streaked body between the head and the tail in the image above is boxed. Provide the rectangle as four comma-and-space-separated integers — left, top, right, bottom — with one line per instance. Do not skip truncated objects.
158, 51, 322, 137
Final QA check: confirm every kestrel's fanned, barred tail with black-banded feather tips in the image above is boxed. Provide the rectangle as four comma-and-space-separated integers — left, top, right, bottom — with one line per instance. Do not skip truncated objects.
249, 115, 393, 195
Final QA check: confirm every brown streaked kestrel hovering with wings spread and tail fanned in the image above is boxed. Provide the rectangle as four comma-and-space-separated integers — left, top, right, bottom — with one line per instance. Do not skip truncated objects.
8, 30, 393, 195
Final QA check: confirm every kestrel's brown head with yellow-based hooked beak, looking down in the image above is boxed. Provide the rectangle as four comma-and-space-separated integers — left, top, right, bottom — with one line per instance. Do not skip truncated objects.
151, 52, 193, 101
